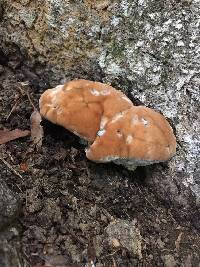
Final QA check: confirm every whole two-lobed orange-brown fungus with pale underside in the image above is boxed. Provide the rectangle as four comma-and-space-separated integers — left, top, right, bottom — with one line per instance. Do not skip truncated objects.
40, 80, 176, 170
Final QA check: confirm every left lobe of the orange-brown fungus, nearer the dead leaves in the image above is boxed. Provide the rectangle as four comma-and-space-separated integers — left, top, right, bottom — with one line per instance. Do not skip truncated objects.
40, 80, 133, 141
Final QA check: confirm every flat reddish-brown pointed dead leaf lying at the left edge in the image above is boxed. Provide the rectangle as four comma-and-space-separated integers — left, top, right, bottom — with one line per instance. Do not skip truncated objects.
0, 129, 30, 145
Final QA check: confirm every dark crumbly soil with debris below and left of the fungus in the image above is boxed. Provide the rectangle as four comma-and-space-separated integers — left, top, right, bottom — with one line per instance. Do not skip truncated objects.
0, 47, 200, 267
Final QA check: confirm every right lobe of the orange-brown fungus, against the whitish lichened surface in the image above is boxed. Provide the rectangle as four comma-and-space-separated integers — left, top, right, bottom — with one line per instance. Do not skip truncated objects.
86, 106, 176, 169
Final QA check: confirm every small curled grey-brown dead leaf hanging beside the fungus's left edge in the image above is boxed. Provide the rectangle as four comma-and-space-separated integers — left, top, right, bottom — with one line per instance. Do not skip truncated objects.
30, 109, 44, 148
